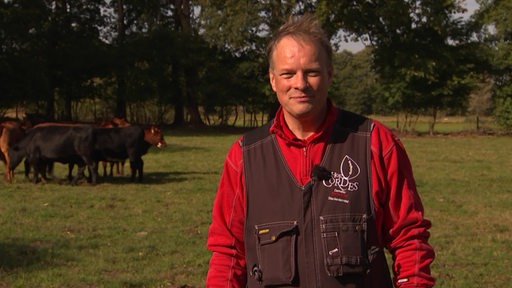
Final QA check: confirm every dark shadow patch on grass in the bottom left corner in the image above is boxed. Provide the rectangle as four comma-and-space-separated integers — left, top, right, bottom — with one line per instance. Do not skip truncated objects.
0, 240, 71, 271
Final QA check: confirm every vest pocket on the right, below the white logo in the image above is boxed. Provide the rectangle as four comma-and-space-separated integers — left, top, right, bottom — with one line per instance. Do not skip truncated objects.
320, 215, 369, 277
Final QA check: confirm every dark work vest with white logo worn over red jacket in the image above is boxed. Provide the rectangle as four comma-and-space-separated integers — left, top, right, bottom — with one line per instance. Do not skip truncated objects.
242, 110, 392, 288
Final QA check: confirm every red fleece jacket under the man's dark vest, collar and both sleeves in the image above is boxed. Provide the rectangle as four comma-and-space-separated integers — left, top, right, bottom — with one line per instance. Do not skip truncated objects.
206, 106, 434, 288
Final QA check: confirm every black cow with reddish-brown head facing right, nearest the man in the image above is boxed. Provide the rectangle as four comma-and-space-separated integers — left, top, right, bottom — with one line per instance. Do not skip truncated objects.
90, 125, 167, 181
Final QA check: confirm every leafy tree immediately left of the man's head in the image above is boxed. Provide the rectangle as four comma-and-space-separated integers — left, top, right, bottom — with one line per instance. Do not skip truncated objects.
198, 0, 314, 120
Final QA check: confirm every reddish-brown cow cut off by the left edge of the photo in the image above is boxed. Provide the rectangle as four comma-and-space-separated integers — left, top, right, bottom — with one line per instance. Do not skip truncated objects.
0, 120, 25, 183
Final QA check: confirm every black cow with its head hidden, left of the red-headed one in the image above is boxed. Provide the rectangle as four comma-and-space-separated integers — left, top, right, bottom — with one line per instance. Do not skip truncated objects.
9, 125, 97, 184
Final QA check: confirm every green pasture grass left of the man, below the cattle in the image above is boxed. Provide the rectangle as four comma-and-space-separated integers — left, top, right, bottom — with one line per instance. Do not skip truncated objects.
0, 132, 237, 287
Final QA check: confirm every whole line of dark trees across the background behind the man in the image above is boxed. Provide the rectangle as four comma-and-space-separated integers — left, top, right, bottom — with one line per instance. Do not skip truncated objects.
0, 0, 512, 131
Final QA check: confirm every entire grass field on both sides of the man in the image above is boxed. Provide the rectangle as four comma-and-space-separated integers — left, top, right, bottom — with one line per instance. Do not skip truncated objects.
0, 126, 512, 287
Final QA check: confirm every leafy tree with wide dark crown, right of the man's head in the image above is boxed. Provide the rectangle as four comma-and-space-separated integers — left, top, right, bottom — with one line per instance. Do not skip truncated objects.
317, 0, 471, 133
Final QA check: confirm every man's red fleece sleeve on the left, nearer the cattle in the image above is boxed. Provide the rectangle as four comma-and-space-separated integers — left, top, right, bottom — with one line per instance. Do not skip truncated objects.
206, 141, 247, 287
